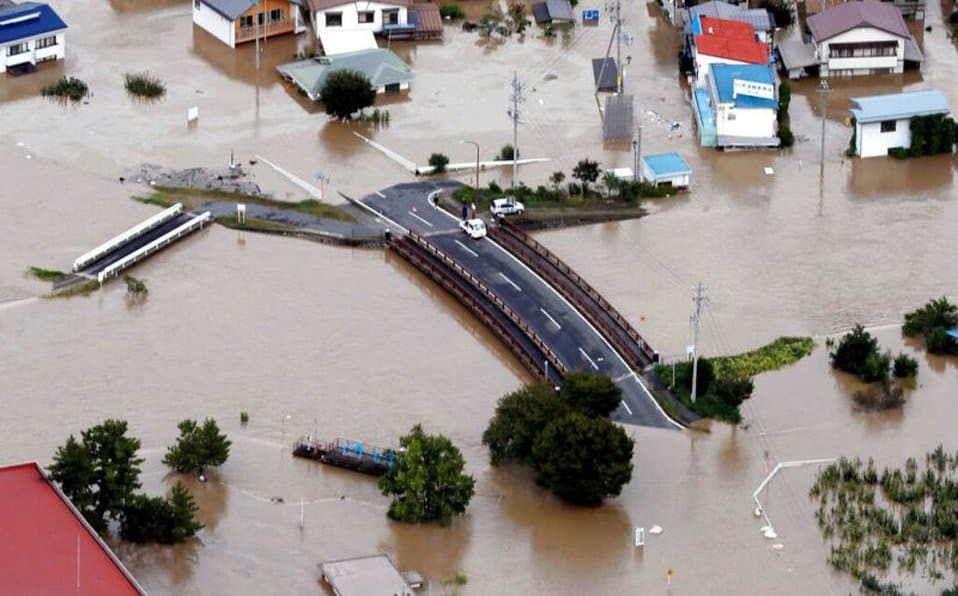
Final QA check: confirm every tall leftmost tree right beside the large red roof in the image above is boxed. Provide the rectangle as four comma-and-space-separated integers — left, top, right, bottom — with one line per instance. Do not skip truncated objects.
50, 419, 143, 533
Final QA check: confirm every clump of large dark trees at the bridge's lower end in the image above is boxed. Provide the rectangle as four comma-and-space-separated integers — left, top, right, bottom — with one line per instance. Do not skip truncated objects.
482, 372, 634, 505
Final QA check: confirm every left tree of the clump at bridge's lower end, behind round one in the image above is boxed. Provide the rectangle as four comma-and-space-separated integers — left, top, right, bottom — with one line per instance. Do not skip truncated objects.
482, 383, 569, 466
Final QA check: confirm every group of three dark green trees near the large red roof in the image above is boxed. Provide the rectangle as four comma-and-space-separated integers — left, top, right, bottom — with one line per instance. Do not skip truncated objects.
49, 419, 230, 544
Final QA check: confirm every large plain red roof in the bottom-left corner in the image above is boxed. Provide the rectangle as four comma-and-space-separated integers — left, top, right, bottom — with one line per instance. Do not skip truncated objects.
0, 463, 146, 596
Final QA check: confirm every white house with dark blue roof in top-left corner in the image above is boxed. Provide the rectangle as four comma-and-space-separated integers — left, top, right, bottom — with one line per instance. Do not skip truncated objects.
0, 0, 67, 74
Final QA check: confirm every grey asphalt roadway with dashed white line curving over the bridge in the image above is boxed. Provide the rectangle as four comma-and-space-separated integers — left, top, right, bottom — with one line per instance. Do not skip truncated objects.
362, 183, 681, 428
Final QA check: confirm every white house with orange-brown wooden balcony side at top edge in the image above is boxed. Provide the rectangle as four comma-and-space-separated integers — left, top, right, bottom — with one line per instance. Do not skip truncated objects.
193, 0, 306, 48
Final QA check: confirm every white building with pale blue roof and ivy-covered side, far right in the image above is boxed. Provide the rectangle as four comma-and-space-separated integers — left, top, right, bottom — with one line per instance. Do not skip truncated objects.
848, 89, 949, 157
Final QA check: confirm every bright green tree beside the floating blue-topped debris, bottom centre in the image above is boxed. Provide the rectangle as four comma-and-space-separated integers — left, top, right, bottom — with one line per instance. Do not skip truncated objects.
379, 424, 476, 526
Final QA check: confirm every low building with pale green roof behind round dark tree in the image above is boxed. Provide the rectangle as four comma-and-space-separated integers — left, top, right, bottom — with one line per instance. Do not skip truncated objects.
276, 48, 413, 101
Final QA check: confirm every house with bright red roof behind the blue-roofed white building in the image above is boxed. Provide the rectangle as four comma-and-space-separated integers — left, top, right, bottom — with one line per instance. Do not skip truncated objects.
692, 16, 768, 87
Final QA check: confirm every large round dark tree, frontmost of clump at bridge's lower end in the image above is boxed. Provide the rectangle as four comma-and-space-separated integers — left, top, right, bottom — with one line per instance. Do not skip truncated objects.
532, 412, 633, 506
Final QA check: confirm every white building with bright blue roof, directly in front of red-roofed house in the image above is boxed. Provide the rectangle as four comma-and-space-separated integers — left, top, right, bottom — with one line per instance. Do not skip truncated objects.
692, 64, 779, 148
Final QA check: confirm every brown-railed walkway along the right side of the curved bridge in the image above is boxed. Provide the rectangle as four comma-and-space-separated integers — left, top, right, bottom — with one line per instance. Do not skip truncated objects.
490, 220, 658, 367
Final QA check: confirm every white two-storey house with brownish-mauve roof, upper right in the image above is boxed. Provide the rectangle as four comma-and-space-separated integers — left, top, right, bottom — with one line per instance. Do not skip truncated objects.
808, 0, 924, 77
